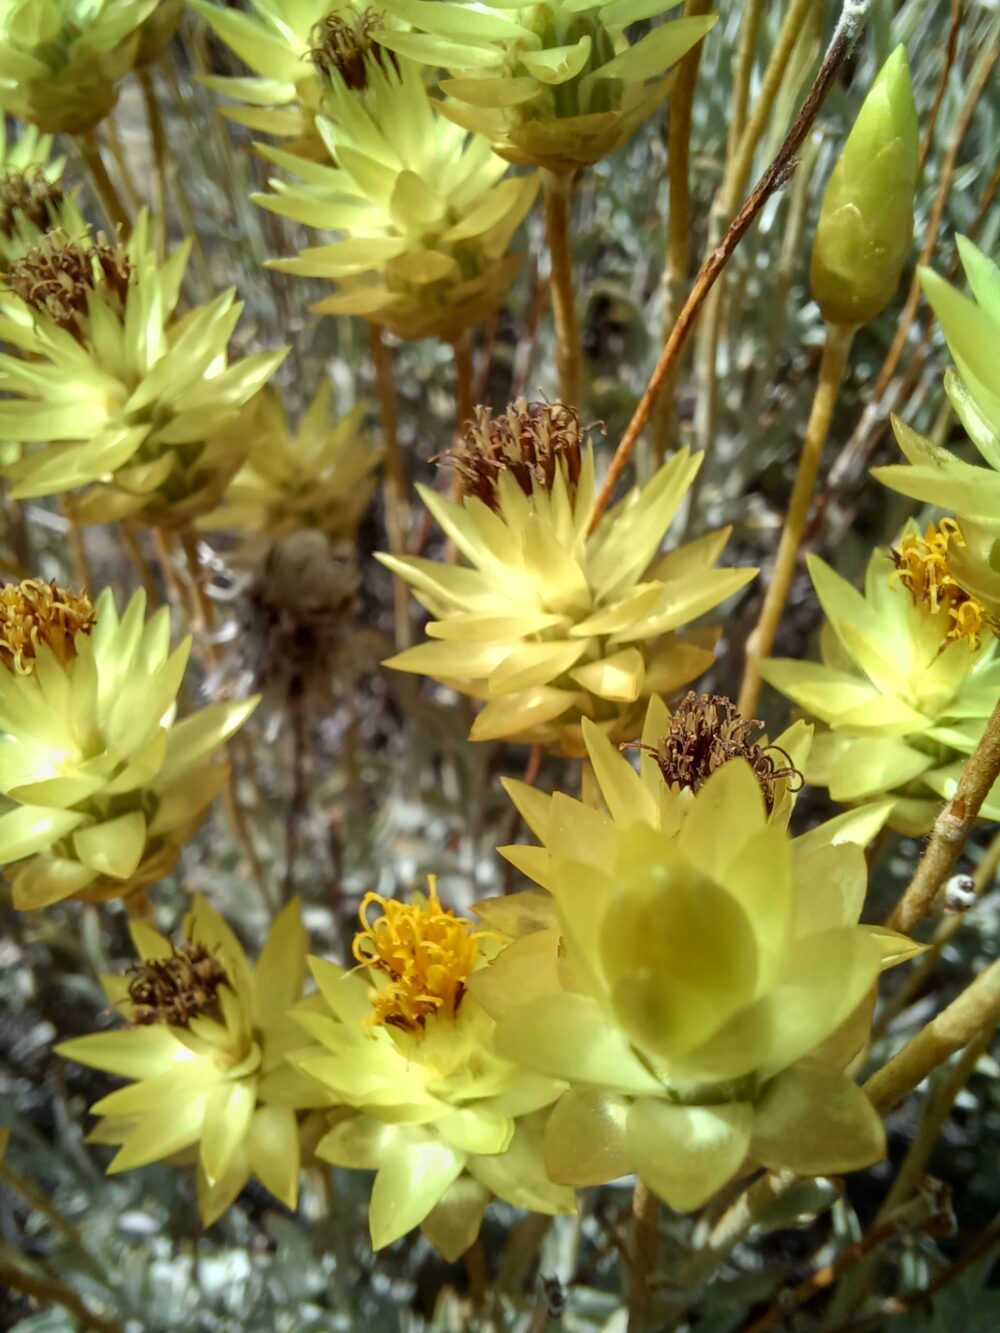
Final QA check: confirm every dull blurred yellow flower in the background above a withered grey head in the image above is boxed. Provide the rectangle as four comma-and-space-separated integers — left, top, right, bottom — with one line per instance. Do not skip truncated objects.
199, 380, 380, 543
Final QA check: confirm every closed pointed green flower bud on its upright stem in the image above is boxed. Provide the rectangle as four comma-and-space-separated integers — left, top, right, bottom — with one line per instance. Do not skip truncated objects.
809, 47, 919, 325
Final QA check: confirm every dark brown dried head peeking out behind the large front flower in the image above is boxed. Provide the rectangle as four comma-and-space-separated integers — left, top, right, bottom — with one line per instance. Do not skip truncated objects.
621, 690, 804, 814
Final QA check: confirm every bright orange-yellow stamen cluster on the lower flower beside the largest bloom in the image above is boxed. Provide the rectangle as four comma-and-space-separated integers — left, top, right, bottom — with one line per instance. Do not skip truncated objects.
352, 876, 488, 1032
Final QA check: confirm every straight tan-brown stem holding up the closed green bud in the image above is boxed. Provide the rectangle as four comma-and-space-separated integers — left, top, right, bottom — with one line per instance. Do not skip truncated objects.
736, 324, 855, 717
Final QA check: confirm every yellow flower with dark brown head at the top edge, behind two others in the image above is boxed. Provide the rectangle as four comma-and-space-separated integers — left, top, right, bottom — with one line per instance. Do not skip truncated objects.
191, 0, 394, 157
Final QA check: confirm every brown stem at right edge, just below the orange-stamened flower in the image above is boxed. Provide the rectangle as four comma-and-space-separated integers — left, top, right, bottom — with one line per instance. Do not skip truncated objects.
887, 702, 1000, 934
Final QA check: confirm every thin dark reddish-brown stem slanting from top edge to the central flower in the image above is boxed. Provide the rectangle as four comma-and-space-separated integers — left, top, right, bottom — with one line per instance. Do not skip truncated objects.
591, 0, 869, 531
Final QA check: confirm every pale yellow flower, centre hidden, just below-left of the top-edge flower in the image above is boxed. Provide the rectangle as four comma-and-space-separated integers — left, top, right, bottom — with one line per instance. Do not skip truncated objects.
253, 59, 539, 339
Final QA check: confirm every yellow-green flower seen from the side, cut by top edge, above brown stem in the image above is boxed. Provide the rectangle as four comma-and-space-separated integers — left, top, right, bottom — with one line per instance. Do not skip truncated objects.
377, 0, 717, 172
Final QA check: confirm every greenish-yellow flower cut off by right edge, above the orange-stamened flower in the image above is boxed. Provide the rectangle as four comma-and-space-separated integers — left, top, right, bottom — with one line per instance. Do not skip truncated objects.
873, 236, 1000, 616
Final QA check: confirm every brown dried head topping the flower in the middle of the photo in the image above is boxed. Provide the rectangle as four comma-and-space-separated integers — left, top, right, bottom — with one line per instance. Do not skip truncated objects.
441, 399, 591, 512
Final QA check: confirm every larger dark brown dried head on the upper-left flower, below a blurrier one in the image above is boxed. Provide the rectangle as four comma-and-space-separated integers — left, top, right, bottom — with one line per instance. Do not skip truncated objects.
5, 231, 132, 343
